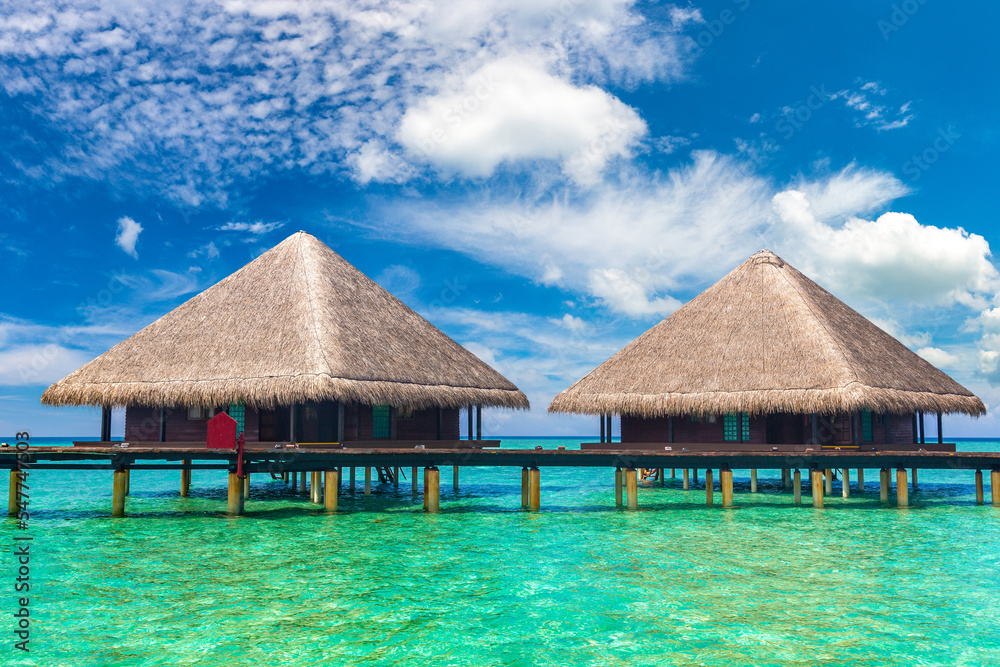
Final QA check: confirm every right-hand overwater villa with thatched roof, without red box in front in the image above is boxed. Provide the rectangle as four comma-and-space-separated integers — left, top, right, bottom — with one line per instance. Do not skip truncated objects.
549, 250, 985, 449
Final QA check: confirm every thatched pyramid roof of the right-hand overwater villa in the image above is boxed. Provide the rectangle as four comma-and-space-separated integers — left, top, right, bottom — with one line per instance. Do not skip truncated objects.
549, 250, 986, 417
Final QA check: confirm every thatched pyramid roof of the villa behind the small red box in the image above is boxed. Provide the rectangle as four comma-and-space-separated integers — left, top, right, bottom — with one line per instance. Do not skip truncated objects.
42, 232, 528, 409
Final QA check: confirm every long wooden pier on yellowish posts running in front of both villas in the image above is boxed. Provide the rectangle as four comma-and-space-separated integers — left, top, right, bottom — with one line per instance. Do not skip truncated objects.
0, 440, 1000, 516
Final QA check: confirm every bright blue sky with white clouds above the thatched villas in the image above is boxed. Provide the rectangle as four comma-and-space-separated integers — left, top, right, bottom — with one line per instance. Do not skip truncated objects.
0, 0, 1000, 436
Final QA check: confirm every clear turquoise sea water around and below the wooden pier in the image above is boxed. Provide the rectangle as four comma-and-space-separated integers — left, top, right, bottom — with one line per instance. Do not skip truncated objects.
0, 439, 1000, 665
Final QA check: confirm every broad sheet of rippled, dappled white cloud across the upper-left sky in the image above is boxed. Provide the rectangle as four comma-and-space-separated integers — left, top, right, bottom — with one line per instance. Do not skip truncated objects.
0, 0, 694, 206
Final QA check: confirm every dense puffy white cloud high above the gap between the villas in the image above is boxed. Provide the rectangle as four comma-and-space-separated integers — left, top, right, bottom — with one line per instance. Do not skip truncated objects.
399, 56, 646, 184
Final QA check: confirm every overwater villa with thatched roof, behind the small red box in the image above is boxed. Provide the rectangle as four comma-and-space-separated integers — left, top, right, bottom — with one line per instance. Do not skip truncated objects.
42, 232, 528, 442
